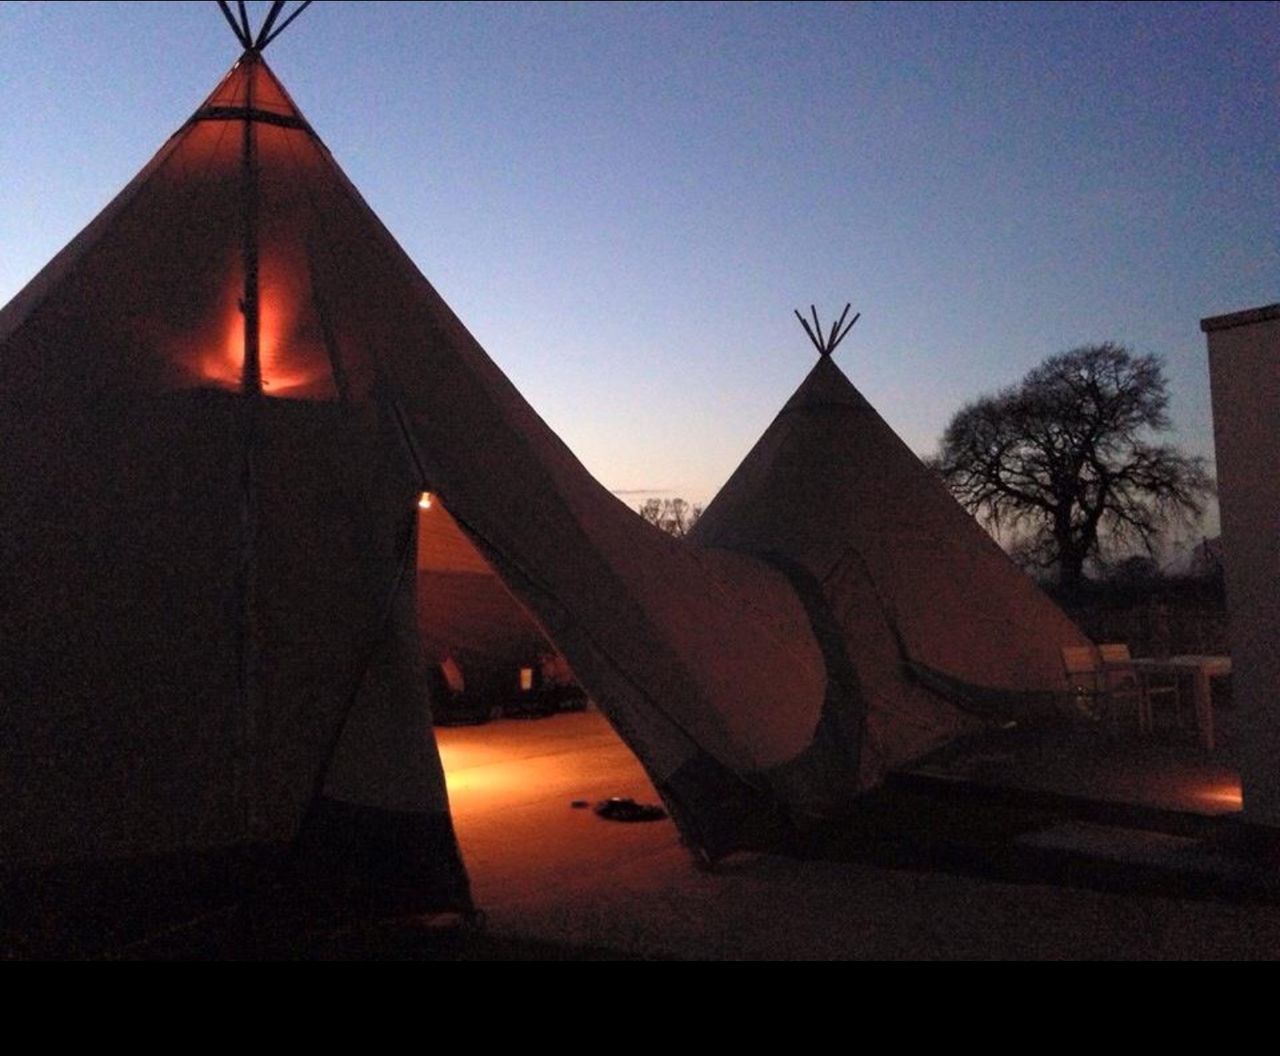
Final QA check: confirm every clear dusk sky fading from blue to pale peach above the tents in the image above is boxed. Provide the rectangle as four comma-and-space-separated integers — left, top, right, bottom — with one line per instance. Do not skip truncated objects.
0, 0, 1280, 542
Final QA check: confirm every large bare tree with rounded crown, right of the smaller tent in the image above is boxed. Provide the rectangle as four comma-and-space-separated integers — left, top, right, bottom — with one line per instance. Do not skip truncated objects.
937, 343, 1213, 589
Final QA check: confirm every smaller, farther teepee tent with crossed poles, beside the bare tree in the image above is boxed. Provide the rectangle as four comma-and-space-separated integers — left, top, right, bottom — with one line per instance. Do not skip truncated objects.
690, 307, 1087, 786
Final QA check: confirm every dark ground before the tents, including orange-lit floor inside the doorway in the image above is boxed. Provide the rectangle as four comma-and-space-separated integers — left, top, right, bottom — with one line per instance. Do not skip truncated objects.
5, 713, 1280, 960
